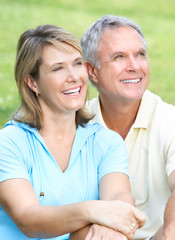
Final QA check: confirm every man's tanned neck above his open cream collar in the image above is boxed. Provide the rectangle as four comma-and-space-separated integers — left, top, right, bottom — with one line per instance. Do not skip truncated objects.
100, 96, 140, 139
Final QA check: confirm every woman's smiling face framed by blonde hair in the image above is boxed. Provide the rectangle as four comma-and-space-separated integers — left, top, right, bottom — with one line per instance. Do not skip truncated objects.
36, 44, 88, 117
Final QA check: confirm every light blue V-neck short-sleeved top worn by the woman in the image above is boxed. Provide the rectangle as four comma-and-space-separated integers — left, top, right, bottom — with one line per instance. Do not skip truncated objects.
0, 121, 128, 240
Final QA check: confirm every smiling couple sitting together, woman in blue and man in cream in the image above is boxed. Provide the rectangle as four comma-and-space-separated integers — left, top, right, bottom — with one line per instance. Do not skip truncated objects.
0, 15, 175, 240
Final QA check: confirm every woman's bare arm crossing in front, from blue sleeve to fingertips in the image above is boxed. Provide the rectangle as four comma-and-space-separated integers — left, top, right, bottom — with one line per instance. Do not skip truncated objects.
0, 175, 143, 239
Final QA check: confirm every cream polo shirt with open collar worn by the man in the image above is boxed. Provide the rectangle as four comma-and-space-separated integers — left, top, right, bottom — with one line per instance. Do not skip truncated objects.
87, 90, 175, 239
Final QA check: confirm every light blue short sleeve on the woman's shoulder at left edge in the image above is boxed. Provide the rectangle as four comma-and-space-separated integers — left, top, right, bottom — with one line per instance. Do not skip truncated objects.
0, 127, 30, 182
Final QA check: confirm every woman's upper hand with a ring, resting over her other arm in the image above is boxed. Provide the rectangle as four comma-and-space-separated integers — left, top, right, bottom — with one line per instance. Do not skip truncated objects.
89, 200, 145, 240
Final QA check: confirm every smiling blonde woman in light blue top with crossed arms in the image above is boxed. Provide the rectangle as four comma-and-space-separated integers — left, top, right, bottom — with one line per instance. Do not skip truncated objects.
0, 25, 144, 240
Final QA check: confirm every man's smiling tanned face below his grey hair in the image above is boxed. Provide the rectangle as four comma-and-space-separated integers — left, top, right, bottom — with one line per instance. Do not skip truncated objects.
95, 26, 150, 102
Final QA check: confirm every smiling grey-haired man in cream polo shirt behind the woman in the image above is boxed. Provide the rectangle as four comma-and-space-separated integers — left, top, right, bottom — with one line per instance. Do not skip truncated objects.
81, 15, 175, 240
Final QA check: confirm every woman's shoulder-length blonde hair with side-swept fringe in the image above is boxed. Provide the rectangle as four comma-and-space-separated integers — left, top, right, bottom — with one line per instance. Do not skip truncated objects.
13, 25, 92, 130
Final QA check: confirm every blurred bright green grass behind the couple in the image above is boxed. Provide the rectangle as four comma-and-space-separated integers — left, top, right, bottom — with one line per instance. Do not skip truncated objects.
0, 0, 175, 128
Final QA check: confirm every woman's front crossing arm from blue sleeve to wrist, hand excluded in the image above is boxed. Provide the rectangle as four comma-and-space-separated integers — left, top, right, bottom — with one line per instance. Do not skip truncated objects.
0, 179, 90, 238
